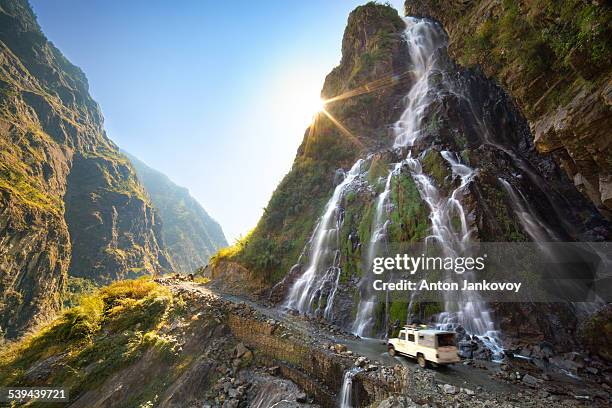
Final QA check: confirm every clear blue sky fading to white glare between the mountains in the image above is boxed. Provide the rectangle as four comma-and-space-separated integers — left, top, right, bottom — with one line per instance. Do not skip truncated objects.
30, 0, 401, 242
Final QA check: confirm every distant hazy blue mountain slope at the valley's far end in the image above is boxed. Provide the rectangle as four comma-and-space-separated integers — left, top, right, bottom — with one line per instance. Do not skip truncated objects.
125, 153, 227, 272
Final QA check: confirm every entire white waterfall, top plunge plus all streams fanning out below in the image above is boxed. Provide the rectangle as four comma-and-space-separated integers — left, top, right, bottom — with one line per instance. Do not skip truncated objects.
286, 17, 501, 355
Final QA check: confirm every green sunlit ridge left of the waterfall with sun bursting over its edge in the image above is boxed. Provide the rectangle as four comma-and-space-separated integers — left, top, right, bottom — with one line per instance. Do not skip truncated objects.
214, 2, 408, 282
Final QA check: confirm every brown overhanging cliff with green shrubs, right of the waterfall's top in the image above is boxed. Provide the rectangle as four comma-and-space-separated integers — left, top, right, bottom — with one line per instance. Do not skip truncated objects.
406, 0, 612, 219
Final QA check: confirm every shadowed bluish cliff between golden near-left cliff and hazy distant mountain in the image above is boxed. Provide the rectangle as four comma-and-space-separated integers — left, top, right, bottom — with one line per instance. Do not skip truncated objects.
64, 150, 171, 283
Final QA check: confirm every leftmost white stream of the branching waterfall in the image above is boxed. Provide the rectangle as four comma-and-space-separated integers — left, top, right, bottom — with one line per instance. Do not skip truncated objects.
285, 159, 363, 318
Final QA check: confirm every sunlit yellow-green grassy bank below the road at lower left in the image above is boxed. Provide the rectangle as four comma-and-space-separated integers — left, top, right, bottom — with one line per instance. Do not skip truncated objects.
0, 278, 175, 395
